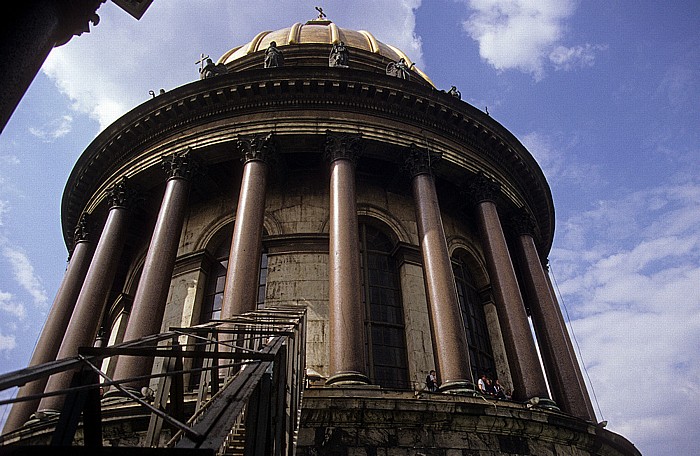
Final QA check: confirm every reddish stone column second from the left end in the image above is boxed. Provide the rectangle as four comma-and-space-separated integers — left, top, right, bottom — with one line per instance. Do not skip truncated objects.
39, 178, 135, 410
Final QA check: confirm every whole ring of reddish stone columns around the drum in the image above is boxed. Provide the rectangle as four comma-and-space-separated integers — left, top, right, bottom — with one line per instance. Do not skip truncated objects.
4, 131, 595, 432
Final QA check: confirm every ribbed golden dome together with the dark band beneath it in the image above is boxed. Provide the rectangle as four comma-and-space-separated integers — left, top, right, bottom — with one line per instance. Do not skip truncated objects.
217, 18, 434, 87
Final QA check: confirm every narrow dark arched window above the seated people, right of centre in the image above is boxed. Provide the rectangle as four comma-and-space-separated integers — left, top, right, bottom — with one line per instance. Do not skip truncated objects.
452, 253, 496, 380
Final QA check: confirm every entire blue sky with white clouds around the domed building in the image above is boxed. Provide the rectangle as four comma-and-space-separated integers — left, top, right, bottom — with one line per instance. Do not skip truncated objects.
0, 0, 700, 455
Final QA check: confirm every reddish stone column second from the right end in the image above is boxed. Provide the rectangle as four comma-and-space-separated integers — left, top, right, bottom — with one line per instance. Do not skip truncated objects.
468, 173, 549, 400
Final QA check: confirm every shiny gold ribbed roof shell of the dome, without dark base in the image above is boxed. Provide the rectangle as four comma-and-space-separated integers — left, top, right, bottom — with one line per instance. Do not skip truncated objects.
217, 19, 434, 86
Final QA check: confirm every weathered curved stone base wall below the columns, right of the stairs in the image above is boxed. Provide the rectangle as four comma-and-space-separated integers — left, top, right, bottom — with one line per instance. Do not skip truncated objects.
296, 388, 641, 456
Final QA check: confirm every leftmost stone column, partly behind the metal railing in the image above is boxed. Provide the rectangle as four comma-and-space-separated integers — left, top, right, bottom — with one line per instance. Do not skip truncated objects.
3, 213, 95, 433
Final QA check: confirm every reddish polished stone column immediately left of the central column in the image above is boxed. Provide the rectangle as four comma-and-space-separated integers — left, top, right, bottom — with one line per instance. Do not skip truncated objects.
221, 134, 275, 320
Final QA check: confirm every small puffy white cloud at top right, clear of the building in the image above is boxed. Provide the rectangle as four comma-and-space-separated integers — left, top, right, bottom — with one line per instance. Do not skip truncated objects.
463, 0, 603, 80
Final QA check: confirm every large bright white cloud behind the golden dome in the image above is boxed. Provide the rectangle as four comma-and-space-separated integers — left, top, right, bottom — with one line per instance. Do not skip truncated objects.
43, 0, 423, 132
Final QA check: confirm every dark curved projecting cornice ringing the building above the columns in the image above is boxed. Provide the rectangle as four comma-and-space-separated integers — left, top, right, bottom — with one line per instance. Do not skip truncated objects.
62, 67, 554, 251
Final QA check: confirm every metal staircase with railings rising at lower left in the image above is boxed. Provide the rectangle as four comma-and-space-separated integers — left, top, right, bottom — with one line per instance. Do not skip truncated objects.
0, 307, 306, 456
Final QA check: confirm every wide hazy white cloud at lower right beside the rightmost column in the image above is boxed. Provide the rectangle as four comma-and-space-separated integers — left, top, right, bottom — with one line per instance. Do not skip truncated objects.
550, 183, 700, 454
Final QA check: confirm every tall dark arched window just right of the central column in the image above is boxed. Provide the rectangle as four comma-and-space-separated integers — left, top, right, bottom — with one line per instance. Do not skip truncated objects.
360, 223, 409, 389
